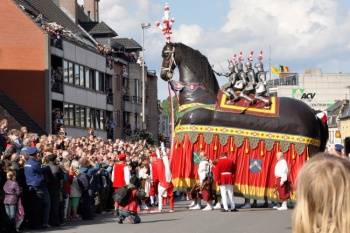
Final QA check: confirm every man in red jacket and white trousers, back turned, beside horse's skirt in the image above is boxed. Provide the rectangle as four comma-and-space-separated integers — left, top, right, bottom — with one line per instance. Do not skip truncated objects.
214, 152, 238, 212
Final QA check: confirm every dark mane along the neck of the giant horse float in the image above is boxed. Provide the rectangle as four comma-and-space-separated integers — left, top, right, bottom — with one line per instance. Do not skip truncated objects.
173, 43, 219, 99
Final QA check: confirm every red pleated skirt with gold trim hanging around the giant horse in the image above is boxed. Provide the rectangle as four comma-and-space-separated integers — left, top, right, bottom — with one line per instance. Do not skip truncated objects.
171, 134, 307, 198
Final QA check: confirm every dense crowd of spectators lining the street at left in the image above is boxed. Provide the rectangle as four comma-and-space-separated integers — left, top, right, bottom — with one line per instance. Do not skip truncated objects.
0, 119, 160, 232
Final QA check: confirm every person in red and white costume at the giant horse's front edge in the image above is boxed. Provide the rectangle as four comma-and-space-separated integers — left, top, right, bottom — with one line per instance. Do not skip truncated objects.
157, 143, 174, 213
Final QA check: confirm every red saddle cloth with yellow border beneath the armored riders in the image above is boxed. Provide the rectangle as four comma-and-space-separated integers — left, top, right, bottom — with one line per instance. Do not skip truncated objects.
215, 90, 280, 117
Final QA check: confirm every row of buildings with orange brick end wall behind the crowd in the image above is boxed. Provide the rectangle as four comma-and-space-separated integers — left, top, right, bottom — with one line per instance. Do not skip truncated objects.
0, 0, 157, 139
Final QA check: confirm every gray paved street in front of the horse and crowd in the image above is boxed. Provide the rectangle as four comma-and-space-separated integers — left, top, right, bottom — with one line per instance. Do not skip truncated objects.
23, 197, 293, 233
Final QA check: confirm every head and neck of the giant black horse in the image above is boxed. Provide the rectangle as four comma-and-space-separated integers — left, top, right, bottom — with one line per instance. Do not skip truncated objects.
160, 43, 219, 104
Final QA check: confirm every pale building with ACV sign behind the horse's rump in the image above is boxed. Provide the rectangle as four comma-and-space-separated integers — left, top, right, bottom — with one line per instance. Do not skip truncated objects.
268, 68, 350, 145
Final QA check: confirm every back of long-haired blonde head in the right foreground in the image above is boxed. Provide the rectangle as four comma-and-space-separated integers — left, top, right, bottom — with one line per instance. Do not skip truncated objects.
293, 153, 350, 233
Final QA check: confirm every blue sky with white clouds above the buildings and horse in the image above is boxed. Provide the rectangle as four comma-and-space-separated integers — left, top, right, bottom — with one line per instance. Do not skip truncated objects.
84, 0, 350, 100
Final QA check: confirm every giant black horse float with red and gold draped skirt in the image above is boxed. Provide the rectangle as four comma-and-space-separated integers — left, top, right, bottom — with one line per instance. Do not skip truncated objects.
160, 42, 328, 201
